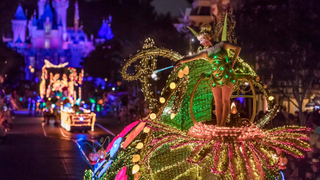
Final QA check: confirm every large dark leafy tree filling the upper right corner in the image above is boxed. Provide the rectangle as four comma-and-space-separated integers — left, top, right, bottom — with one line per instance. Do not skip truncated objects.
237, 0, 320, 125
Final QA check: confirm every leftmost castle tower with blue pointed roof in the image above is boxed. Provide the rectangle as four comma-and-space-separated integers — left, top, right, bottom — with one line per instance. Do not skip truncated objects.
11, 5, 27, 42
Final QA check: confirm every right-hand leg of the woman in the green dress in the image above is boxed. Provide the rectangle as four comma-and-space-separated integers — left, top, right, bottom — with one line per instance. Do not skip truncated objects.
221, 84, 233, 126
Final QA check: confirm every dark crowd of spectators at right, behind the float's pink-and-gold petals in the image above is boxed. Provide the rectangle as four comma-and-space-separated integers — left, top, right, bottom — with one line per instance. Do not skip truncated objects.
257, 107, 320, 180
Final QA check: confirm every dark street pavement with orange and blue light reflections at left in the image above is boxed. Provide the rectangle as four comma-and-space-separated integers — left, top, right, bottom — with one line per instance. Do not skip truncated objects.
0, 110, 123, 180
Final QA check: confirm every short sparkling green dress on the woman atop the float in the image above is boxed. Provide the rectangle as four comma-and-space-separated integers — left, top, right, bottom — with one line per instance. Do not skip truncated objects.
204, 42, 236, 87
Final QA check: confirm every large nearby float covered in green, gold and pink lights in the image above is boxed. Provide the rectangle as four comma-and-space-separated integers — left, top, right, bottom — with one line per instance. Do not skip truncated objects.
84, 11, 310, 180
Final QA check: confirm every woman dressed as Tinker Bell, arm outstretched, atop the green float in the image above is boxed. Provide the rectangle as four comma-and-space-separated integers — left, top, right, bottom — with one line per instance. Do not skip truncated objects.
175, 24, 241, 126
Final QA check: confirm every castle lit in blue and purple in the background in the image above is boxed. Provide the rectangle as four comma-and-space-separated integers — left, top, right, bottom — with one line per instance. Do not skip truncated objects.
3, 0, 113, 80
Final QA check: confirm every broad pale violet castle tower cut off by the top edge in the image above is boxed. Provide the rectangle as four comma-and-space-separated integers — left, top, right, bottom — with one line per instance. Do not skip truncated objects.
52, 0, 69, 41
